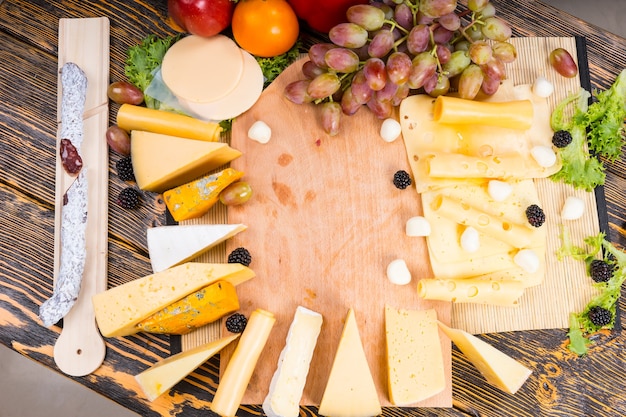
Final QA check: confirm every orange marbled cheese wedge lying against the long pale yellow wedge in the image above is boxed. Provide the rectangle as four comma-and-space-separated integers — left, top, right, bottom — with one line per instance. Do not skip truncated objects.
137, 281, 239, 334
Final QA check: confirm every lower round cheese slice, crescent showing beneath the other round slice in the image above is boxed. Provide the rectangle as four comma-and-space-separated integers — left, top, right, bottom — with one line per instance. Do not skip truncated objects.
178, 50, 264, 120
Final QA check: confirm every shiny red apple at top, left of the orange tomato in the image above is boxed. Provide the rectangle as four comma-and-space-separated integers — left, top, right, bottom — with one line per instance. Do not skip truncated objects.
167, 0, 235, 37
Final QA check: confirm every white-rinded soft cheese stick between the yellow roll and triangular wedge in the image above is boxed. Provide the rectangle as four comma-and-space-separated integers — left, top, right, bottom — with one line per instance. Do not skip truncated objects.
263, 306, 323, 417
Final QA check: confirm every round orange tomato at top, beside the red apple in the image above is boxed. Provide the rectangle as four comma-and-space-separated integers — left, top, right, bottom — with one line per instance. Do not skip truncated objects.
231, 0, 300, 58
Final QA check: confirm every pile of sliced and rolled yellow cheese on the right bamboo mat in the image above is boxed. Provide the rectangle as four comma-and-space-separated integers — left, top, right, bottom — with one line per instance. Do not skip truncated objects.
400, 82, 560, 306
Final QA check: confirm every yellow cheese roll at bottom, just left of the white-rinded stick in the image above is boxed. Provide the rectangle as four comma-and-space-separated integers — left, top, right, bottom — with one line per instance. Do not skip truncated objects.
211, 309, 276, 417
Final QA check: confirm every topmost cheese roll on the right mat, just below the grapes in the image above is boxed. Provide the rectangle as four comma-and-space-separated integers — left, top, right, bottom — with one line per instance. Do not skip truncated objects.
433, 96, 533, 130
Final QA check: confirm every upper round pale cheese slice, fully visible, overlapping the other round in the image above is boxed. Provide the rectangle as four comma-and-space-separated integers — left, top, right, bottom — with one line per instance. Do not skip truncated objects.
161, 35, 244, 103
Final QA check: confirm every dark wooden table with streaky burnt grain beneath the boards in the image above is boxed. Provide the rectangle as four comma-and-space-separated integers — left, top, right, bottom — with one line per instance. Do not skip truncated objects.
0, 0, 626, 417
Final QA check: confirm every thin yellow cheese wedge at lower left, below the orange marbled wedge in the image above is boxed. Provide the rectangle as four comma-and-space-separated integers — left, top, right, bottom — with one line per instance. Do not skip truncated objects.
135, 334, 239, 401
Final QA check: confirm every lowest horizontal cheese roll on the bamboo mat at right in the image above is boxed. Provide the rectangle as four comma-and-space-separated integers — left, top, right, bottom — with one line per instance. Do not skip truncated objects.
417, 278, 524, 307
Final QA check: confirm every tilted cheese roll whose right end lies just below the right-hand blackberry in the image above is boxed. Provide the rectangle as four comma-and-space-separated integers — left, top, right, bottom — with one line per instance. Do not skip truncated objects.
431, 195, 533, 248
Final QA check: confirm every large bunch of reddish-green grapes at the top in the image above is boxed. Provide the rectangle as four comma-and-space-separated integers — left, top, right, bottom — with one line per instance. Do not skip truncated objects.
285, 0, 517, 135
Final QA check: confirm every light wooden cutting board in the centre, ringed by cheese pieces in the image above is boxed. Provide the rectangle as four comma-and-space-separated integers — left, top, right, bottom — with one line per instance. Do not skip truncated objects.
221, 60, 452, 407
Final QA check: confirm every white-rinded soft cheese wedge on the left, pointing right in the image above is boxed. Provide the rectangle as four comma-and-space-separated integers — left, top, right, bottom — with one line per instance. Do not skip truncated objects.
147, 224, 247, 272
